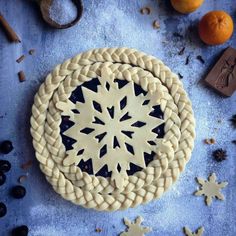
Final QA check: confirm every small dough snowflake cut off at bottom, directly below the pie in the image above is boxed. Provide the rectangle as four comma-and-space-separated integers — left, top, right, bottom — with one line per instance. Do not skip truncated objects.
120, 216, 152, 236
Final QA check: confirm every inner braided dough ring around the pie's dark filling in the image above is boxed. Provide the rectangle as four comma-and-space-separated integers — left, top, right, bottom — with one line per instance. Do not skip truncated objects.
45, 63, 180, 194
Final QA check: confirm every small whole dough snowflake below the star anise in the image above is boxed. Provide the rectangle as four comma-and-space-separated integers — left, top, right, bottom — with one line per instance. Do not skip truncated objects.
195, 173, 228, 206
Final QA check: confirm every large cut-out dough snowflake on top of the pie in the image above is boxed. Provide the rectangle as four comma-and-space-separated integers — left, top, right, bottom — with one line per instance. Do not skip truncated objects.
56, 68, 165, 188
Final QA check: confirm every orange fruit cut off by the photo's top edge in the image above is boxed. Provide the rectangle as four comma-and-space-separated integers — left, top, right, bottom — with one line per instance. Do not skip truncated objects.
171, 0, 204, 14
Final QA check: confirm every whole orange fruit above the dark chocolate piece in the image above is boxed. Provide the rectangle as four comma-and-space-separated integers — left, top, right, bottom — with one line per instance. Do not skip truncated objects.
198, 11, 234, 45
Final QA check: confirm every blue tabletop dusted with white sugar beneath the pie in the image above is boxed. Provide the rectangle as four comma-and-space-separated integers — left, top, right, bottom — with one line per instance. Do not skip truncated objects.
0, 0, 236, 236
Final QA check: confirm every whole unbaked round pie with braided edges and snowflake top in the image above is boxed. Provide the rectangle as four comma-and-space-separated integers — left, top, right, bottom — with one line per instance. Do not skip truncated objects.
31, 48, 195, 211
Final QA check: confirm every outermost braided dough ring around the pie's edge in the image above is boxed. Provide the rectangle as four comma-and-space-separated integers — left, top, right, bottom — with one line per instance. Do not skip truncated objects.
31, 48, 195, 211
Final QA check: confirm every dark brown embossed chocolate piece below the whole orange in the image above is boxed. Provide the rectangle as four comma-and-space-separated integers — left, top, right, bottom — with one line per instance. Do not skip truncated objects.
205, 47, 236, 97
